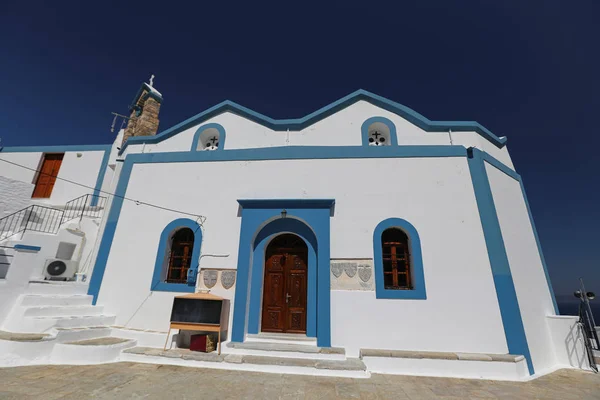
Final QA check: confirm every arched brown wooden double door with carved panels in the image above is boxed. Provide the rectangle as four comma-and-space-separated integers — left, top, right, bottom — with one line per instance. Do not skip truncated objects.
261, 234, 308, 333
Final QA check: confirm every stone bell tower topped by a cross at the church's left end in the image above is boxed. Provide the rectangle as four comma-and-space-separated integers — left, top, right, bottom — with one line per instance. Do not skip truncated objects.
123, 75, 162, 144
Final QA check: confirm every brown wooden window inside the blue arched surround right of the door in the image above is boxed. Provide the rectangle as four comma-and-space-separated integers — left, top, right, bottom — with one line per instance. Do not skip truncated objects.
381, 228, 412, 290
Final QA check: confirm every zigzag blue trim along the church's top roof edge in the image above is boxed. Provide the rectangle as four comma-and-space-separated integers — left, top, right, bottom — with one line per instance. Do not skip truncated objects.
119, 89, 506, 154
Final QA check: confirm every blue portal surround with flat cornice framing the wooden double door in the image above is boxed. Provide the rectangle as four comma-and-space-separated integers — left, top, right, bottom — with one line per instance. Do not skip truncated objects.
231, 199, 334, 347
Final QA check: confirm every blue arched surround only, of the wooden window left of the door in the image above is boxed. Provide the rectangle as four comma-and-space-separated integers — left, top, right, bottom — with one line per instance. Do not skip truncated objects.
150, 218, 202, 293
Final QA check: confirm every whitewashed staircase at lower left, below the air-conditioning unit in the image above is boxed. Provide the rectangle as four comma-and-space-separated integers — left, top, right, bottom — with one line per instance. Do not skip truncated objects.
0, 282, 124, 366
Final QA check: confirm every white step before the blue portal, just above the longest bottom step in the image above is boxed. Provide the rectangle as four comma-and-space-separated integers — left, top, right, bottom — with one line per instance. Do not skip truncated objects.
227, 341, 346, 360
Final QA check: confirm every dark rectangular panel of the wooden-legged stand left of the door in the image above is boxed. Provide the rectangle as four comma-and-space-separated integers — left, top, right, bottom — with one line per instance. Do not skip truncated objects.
171, 297, 223, 325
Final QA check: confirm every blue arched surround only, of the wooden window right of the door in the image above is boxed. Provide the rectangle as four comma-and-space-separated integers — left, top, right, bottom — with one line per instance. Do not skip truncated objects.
373, 218, 427, 300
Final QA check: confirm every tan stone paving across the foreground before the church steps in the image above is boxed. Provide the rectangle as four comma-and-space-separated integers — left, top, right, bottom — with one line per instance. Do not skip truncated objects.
0, 363, 600, 400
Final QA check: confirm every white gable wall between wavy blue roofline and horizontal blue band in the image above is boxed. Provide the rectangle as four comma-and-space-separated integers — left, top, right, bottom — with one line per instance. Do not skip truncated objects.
126, 101, 512, 156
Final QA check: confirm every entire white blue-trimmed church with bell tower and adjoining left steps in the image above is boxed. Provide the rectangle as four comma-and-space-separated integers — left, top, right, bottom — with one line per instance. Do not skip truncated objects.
0, 79, 587, 380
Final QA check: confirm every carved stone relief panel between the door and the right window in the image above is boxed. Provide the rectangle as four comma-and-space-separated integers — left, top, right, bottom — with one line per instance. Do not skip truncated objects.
331, 258, 375, 290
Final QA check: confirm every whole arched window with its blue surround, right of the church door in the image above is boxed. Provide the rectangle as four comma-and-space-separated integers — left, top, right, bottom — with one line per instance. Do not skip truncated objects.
373, 218, 427, 300
